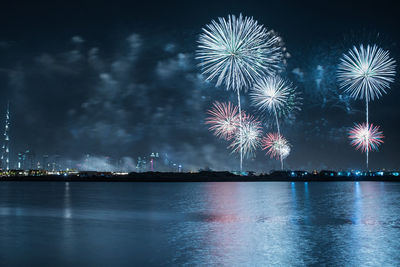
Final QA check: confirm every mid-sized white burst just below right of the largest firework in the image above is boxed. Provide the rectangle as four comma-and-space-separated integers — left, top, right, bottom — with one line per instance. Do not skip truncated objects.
250, 76, 300, 116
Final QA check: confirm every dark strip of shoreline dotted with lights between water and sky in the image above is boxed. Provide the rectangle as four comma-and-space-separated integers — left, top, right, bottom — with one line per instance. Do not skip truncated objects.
0, 171, 400, 182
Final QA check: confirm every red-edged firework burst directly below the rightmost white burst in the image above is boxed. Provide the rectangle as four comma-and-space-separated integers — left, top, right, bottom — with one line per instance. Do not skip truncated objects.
349, 123, 384, 153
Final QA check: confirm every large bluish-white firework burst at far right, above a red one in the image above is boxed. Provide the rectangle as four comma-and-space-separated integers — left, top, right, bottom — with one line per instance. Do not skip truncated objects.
337, 45, 396, 101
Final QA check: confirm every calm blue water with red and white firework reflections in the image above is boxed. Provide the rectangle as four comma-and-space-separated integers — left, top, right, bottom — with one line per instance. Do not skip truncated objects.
0, 182, 400, 266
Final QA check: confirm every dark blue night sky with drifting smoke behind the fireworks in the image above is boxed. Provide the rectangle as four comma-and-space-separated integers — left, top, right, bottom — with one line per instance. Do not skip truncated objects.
0, 1, 400, 171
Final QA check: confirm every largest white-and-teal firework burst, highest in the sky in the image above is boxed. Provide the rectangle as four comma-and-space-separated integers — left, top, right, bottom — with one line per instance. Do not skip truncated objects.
196, 14, 285, 91
